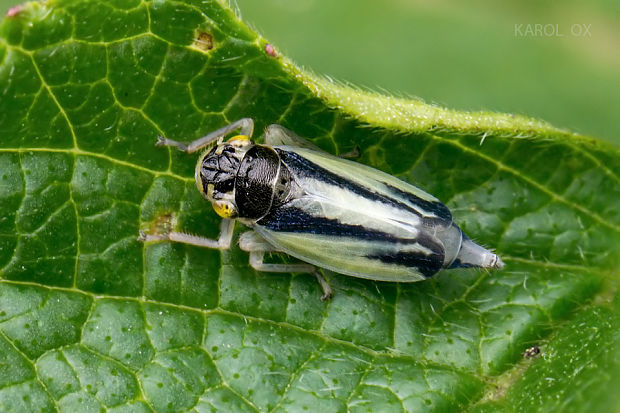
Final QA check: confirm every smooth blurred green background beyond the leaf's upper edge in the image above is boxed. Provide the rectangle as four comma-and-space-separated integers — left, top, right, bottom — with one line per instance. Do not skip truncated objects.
0, 0, 620, 146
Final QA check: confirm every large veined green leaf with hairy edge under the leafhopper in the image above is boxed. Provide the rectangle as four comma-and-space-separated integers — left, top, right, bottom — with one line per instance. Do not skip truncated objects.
0, 0, 620, 411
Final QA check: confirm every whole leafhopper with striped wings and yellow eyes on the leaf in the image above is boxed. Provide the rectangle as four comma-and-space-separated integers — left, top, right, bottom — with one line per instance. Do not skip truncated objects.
140, 118, 504, 299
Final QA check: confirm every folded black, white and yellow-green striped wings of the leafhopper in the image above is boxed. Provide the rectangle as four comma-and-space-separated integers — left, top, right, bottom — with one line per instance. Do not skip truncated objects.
254, 146, 461, 282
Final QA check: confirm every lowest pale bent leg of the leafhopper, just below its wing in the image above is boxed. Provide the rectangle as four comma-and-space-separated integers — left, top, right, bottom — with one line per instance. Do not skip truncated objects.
239, 231, 332, 301
